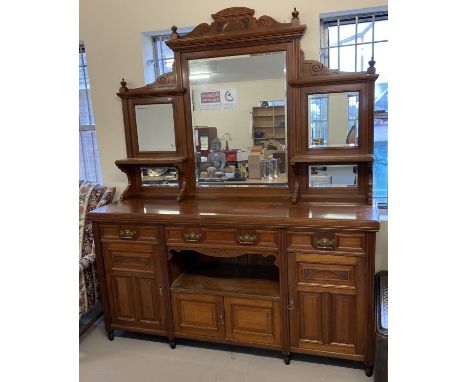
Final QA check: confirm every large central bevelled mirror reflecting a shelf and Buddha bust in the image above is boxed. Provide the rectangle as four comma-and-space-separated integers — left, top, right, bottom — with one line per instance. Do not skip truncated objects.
189, 52, 288, 187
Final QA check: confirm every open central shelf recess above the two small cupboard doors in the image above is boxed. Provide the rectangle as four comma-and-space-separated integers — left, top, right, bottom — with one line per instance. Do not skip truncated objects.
171, 263, 280, 300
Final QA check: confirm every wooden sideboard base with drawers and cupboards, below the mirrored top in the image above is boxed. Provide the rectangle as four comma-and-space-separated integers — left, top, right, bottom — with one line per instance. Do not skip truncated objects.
89, 199, 379, 373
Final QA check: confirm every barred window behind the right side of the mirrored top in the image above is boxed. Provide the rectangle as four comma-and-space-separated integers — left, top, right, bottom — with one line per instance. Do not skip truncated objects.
320, 7, 388, 206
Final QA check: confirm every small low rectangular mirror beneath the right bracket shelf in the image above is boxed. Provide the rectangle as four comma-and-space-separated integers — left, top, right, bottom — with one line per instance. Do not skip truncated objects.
309, 165, 358, 188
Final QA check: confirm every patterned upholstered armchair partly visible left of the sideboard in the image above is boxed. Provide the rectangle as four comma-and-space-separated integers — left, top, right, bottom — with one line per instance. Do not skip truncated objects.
79, 181, 115, 318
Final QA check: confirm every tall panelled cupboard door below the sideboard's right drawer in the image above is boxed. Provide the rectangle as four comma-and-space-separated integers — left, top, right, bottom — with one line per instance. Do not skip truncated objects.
288, 253, 366, 358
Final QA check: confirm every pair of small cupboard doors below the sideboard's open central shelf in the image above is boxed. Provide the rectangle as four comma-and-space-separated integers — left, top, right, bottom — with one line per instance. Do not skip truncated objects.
172, 292, 281, 345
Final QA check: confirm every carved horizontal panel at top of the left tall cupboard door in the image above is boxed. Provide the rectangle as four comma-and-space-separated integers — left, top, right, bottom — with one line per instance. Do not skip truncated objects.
102, 242, 156, 273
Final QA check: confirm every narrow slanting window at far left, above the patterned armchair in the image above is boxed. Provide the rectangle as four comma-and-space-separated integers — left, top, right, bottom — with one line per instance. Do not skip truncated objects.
79, 44, 102, 183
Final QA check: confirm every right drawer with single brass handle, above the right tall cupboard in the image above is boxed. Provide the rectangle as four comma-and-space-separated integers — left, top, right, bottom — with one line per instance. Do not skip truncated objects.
288, 231, 366, 253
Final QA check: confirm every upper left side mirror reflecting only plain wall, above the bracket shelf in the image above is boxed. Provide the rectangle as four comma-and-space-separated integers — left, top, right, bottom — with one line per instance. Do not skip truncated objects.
135, 103, 176, 151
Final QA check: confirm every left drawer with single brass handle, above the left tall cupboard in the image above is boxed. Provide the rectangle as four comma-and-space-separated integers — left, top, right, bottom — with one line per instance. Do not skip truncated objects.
100, 224, 159, 241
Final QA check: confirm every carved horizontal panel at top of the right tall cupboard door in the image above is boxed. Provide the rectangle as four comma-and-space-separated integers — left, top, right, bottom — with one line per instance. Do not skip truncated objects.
294, 253, 358, 287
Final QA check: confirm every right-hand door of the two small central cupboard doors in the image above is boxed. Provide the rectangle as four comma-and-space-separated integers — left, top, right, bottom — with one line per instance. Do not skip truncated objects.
224, 297, 281, 345
